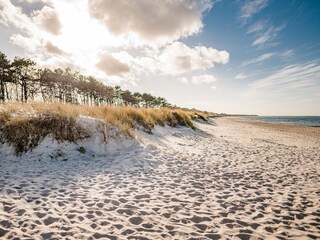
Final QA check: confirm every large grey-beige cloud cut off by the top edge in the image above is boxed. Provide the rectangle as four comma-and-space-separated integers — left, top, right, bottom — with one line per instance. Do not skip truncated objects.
88, 0, 212, 43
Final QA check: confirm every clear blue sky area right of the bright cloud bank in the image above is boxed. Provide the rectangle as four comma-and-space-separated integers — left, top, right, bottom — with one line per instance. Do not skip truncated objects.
178, 0, 320, 115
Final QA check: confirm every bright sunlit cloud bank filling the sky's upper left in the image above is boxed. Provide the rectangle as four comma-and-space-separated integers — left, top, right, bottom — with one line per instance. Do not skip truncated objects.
0, 0, 230, 84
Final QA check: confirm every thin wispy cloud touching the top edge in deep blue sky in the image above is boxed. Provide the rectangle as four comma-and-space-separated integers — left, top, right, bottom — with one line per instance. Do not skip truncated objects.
240, 0, 269, 23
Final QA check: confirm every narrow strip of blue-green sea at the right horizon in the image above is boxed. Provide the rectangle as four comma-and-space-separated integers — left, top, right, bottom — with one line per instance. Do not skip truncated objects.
246, 116, 320, 127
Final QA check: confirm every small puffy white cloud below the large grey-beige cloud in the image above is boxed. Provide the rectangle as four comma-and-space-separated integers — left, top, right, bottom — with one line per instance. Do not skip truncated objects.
159, 42, 229, 75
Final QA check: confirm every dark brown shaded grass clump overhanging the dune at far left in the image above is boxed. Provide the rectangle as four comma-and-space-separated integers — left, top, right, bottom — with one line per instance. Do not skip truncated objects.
0, 113, 89, 155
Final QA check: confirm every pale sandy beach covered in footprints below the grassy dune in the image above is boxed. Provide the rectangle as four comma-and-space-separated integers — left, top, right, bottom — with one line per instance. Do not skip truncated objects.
0, 118, 320, 240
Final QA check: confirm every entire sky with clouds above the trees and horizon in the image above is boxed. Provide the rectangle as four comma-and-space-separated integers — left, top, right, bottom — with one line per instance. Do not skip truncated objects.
0, 0, 320, 116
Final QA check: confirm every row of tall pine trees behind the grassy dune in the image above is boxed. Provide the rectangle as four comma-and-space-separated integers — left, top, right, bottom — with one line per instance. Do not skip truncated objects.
0, 52, 171, 107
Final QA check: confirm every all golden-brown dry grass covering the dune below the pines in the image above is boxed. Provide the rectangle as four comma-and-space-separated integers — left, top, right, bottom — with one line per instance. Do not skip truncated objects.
0, 102, 206, 155
